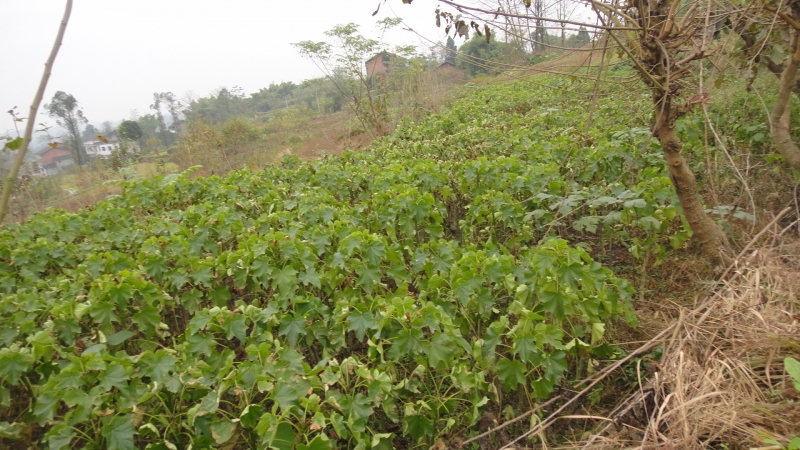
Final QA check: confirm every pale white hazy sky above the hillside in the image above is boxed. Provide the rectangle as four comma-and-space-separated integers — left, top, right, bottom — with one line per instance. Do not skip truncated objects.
0, 0, 446, 135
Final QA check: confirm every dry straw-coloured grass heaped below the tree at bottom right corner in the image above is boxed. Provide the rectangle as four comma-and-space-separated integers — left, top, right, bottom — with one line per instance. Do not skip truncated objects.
520, 241, 800, 450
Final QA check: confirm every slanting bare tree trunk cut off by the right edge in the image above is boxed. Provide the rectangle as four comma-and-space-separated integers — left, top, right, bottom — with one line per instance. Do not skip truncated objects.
769, 30, 800, 170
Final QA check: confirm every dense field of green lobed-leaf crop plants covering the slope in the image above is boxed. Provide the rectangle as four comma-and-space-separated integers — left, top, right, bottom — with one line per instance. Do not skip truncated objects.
0, 76, 688, 449
